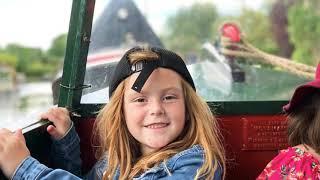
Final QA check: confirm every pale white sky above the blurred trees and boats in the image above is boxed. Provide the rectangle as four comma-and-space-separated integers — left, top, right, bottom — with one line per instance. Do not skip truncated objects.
0, 0, 265, 50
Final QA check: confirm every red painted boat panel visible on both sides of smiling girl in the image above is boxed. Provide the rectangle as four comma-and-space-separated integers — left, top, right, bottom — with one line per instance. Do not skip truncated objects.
76, 115, 288, 180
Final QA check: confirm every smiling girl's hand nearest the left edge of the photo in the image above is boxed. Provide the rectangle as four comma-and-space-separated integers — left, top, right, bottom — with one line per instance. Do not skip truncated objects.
0, 129, 30, 178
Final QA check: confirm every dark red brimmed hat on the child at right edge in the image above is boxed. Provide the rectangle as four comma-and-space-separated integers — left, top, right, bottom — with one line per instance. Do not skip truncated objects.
283, 63, 320, 113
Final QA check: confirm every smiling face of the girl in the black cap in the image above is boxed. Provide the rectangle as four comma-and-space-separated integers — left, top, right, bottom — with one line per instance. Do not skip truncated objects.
123, 68, 185, 154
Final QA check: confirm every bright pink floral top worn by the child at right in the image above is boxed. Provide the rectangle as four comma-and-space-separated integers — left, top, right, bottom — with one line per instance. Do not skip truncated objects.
257, 147, 320, 180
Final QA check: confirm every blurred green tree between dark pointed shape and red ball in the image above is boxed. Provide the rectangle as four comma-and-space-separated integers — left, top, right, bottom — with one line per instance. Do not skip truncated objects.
162, 3, 218, 55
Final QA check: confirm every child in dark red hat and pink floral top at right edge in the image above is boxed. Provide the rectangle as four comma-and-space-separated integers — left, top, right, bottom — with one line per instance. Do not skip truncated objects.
257, 64, 320, 179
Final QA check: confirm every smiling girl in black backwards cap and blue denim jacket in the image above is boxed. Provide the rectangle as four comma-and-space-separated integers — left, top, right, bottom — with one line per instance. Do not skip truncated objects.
0, 47, 226, 179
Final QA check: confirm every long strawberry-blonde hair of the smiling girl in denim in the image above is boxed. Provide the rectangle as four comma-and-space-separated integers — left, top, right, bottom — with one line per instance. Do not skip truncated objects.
95, 50, 226, 180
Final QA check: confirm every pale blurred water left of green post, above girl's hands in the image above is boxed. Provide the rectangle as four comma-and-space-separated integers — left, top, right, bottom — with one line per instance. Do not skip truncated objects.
0, 82, 52, 130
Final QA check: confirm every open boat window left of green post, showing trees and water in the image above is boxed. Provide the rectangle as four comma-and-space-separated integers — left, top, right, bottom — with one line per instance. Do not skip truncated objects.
0, 0, 72, 131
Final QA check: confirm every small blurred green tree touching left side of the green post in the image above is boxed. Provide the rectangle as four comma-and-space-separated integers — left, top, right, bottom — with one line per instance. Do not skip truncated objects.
47, 34, 67, 58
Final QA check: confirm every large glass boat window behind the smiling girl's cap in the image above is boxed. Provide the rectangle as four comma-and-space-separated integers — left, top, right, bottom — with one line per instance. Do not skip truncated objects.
81, 0, 320, 104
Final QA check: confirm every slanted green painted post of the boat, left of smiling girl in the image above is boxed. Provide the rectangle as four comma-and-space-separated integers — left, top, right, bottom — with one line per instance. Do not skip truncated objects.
58, 0, 95, 110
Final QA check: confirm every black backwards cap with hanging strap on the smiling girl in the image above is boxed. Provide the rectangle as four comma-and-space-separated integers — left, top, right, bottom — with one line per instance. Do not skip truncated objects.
109, 47, 196, 98
